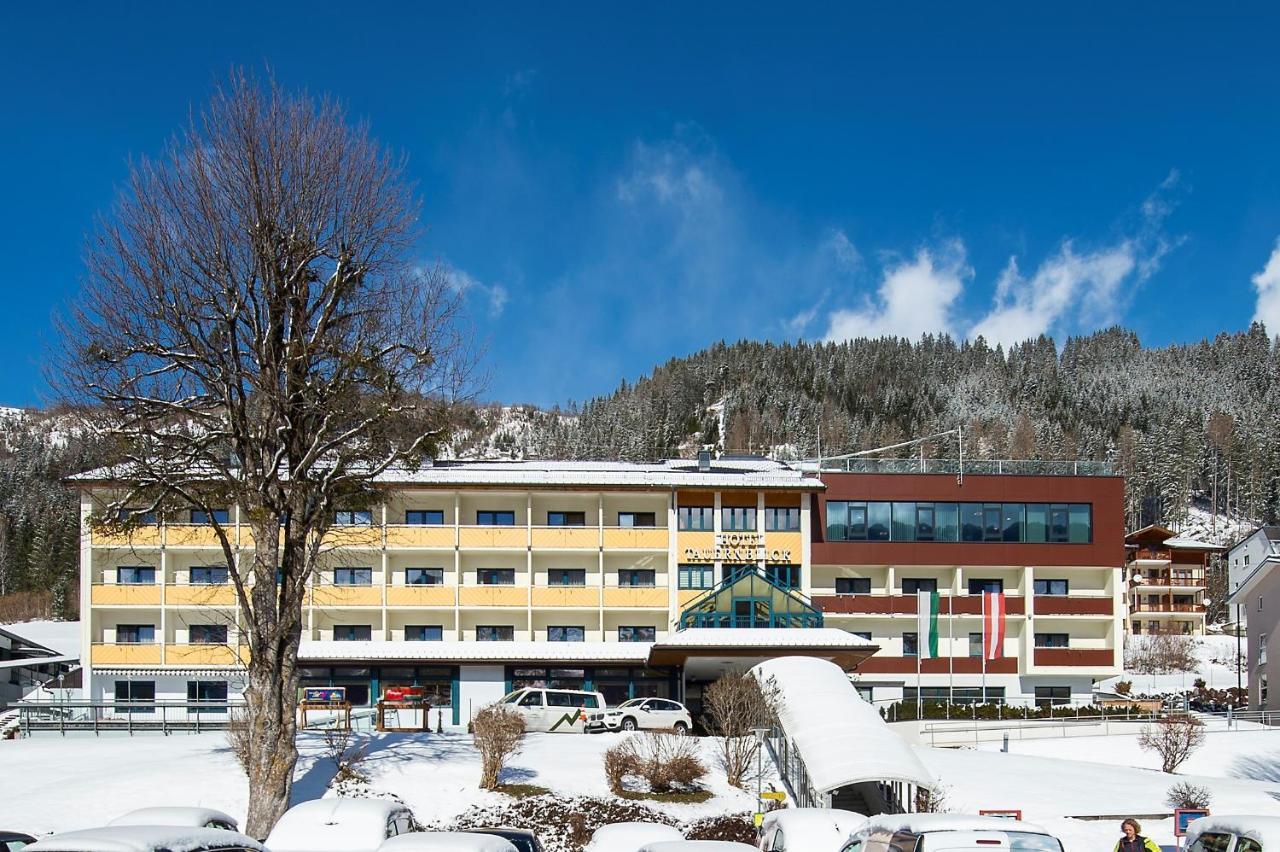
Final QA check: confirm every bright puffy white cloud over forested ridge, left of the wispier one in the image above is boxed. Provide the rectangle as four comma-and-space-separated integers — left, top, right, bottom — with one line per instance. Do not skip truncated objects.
826, 239, 973, 340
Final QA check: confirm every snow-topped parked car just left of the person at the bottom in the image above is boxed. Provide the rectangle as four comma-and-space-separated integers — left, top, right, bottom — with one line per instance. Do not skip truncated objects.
841, 814, 1062, 852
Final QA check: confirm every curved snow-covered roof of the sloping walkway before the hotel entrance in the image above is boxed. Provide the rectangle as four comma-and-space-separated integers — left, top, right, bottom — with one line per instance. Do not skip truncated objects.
747, 652, 933, 793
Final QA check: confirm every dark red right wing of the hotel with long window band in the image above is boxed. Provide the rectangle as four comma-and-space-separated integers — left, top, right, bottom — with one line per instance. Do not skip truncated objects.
805, 459, 1125, 704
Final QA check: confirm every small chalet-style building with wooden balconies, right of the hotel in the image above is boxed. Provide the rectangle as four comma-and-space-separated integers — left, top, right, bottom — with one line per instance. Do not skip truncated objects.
1125, 525, 1226, 636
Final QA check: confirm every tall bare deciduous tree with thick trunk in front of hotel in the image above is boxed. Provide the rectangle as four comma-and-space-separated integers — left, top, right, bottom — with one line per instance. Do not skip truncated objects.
51, 74, 467, 838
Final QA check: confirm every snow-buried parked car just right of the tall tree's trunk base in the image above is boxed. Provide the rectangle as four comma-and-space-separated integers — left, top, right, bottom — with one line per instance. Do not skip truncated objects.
266, 798, 416, 852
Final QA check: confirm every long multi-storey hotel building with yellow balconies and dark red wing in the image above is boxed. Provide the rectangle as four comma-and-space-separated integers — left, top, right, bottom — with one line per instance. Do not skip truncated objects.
73, 458, 1124, 724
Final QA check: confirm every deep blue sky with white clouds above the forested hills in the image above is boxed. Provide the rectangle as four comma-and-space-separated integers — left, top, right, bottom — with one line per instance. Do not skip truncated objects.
0, 3, 1280, 404
